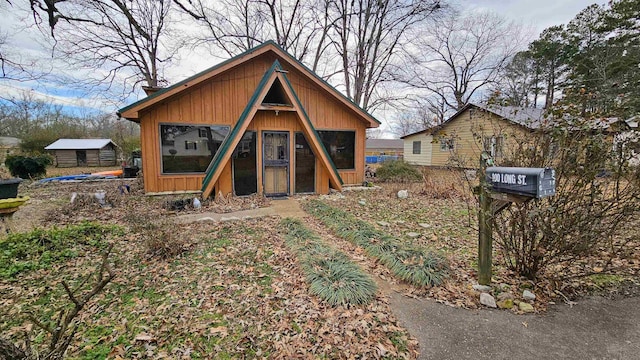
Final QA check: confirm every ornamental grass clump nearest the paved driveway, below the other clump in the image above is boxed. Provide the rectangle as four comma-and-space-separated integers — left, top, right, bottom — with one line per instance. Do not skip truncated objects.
281, 219, 377, 306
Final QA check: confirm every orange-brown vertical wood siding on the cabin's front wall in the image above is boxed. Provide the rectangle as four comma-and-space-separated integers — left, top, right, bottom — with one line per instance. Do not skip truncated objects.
140, 53, 366, 194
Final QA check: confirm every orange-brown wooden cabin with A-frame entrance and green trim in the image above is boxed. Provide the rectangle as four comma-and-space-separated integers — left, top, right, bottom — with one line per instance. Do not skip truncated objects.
118, 41, 380, 197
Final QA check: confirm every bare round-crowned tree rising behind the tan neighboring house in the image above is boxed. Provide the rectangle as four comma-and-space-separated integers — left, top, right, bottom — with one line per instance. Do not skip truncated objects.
403, 11, 524, 110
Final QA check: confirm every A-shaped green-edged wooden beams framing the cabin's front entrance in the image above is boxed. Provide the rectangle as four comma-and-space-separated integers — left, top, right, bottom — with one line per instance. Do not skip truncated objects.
202, 60, 342, 198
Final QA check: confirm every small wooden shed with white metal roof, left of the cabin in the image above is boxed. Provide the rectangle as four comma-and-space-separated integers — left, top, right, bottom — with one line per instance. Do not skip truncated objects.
44, 139, 118, 167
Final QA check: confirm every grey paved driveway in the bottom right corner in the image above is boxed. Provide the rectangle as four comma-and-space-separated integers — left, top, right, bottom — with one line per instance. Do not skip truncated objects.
390, 292, 640, 360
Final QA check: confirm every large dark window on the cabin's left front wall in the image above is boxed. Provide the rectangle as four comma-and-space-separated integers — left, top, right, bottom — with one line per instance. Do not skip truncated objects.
160, 124, 229, 174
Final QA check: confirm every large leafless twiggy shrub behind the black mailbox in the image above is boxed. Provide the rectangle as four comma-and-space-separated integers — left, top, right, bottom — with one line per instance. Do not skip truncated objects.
494, 119, 640, 279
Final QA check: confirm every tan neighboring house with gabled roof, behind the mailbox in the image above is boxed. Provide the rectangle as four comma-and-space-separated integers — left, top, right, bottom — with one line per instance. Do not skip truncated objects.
402, 103, 546, 168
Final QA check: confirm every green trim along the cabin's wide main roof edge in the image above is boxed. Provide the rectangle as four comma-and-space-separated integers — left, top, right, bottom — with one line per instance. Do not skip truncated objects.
116, 40, 382, 124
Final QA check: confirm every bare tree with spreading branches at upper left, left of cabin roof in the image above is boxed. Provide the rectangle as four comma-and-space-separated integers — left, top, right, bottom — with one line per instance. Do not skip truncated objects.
30, 0, 180, 91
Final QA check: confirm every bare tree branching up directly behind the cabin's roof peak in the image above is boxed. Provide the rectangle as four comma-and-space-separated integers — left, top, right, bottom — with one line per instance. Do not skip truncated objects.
175, 0, 332, 71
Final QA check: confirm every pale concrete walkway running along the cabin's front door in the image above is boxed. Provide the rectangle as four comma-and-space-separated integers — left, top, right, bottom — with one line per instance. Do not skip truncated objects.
177, 198, 305, 223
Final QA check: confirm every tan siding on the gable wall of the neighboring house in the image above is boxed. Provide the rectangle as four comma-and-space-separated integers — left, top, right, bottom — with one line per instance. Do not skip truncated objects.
431, 108, 529, 168
